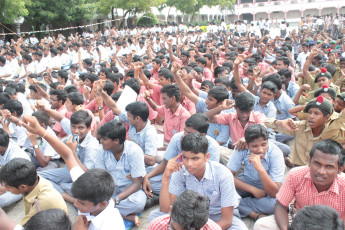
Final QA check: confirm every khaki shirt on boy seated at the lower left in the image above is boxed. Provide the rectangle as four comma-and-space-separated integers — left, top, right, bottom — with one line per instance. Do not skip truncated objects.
20, 176, 67, 225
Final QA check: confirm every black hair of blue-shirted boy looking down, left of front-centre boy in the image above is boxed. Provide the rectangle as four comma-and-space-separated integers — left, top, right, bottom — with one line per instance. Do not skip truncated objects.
98, 120, 126, 144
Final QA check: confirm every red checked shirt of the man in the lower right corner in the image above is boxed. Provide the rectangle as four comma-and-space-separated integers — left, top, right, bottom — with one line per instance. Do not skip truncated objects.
277, 166, 345, 221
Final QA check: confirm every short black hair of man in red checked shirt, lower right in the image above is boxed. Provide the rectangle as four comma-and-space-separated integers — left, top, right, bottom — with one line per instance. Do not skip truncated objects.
310, 139, 345, 167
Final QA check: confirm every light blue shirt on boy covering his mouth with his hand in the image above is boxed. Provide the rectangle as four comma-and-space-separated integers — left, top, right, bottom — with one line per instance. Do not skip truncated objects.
227, 141, 285, 185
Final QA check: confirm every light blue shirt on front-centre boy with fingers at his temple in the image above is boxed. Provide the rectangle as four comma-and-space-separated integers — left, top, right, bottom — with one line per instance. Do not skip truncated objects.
169, 161, 241, 215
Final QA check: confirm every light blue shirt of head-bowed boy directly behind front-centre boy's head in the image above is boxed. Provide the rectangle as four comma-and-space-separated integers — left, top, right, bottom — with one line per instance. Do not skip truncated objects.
164, 132, 220, 162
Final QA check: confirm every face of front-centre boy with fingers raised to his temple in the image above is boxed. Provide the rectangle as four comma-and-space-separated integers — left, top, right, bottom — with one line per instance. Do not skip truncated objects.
182, 151, 210, 176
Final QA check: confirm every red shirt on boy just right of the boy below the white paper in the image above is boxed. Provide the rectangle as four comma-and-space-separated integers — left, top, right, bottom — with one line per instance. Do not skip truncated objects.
156, 105, 190, 143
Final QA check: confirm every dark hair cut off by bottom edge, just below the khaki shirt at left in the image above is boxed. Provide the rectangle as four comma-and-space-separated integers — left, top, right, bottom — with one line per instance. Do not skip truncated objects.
23, 208, 72, 230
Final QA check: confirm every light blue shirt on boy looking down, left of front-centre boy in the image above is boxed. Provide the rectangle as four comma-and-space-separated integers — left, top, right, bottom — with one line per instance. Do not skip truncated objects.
95, 140, 146, 195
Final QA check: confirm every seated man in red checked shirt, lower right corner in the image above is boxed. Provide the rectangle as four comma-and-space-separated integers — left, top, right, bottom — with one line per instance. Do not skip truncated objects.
254, 139, 345, 230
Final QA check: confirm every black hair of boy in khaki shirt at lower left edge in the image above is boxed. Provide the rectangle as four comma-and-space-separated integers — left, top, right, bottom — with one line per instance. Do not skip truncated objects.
0, 158, 38, 188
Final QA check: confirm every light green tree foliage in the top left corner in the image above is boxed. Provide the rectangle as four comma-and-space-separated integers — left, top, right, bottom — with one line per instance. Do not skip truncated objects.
0, 0, 28, 24
